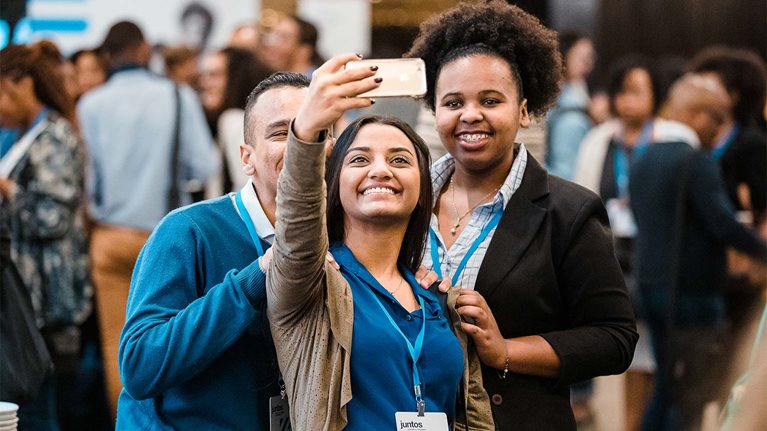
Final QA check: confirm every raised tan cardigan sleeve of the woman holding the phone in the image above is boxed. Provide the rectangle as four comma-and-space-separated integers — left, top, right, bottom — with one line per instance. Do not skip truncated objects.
266, 122, 328, 327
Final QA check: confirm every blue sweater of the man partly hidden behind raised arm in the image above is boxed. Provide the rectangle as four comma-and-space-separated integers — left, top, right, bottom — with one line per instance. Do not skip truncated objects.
116, 196, 278, 430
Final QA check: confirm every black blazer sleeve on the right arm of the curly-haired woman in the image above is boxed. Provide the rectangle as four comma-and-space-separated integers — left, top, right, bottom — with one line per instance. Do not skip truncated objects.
541, 196, 639, 384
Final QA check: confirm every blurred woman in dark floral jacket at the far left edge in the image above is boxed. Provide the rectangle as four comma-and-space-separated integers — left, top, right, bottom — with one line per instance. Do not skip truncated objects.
0, 41, 92, 430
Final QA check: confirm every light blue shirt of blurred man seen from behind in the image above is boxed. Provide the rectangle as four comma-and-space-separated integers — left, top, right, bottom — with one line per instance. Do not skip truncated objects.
77, 68, 220, 230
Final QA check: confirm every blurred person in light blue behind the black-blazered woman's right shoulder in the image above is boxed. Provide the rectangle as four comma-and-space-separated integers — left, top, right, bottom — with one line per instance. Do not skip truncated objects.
546, 31, 595, 180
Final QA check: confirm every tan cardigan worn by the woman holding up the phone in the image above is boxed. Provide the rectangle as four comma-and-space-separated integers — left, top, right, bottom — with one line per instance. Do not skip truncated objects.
266, 128, 495, 431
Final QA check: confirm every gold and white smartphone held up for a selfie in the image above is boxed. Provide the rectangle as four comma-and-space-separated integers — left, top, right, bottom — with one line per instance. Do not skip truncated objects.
346, 58, 426, 97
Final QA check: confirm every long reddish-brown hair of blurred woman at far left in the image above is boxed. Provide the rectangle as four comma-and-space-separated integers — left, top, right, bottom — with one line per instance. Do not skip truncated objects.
0, 40, 78, 130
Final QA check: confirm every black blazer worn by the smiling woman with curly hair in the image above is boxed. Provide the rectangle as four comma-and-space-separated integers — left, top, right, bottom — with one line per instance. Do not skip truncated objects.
475, 156, 639, 431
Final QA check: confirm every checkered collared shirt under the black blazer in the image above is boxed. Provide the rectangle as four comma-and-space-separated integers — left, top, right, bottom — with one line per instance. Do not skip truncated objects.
423, 144, 527, 289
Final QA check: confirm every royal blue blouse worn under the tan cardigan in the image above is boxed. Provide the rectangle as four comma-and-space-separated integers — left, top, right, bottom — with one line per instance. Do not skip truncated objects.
330, 244, 463, 431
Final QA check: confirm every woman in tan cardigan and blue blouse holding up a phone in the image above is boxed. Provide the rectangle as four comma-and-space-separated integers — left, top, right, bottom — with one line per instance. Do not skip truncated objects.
261, 55, 493, 430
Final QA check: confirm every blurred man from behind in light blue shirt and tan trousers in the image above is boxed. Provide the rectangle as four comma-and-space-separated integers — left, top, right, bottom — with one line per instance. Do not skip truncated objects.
78, 21, 219, 418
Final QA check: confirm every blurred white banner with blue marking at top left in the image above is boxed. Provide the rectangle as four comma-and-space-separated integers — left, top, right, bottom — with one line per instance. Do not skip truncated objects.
0, 0, 261, 54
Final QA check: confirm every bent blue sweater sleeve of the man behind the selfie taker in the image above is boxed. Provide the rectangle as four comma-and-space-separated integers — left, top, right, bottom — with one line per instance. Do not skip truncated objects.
118, 212, 265, 400
